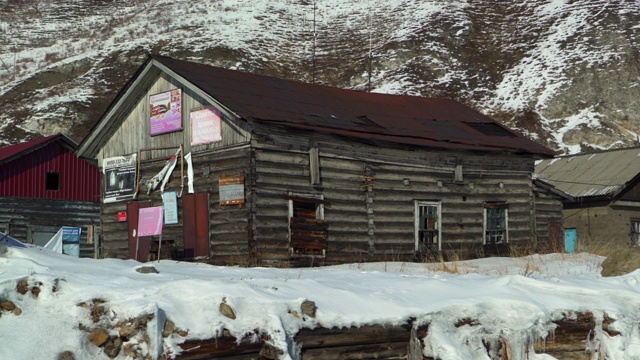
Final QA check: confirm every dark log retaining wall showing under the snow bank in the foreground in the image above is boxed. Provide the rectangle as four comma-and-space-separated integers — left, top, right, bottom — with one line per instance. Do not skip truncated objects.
176, 313, 621, 360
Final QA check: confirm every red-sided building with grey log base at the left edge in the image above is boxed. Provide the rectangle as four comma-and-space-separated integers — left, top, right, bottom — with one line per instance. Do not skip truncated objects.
0, 134, 100, 256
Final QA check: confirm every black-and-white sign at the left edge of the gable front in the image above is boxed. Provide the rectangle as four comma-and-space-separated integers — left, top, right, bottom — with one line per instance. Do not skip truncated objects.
102, 154, 137, 203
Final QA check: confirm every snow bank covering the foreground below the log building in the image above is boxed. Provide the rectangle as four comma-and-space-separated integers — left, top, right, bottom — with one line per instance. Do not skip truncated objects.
0, 236, 640, 360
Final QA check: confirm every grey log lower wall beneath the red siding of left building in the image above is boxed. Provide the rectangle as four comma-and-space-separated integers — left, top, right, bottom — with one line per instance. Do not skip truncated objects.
0, 197, 100, 257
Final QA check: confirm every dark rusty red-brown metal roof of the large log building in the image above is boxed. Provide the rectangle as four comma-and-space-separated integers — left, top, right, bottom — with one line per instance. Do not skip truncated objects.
153, 56, 554, 158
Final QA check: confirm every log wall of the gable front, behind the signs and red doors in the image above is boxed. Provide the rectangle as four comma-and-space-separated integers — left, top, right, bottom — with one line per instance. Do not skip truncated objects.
97, 146, 252, 264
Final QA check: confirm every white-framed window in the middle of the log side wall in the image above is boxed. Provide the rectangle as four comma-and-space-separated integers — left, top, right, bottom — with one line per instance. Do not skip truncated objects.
415, 201, 442, 252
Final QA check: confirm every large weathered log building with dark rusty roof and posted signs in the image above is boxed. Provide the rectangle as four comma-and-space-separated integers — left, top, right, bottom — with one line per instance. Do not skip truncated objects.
77, 56, 554, 266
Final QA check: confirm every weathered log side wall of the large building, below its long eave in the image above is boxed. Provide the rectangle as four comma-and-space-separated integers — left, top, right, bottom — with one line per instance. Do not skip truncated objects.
254, 122, 533, 264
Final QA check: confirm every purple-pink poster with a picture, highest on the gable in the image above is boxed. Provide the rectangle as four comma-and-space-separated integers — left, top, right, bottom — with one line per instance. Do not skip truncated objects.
149, 89, 182, 136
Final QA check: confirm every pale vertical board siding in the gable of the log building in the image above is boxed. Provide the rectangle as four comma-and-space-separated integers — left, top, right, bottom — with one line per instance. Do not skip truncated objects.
98, 75, 250, 166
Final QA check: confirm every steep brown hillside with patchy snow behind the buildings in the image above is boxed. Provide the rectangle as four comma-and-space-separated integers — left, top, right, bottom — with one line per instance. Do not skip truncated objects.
0, 0, 640, 152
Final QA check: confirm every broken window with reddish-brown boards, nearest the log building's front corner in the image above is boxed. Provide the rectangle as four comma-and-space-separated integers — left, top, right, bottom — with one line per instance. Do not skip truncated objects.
286, 195, 328, 256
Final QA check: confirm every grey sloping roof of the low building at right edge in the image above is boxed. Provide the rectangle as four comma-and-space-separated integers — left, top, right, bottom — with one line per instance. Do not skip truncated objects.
535, 147, 640, 198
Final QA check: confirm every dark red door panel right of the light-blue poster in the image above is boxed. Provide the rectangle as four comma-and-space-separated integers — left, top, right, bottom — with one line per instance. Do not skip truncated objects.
182, 192, 209, 259
